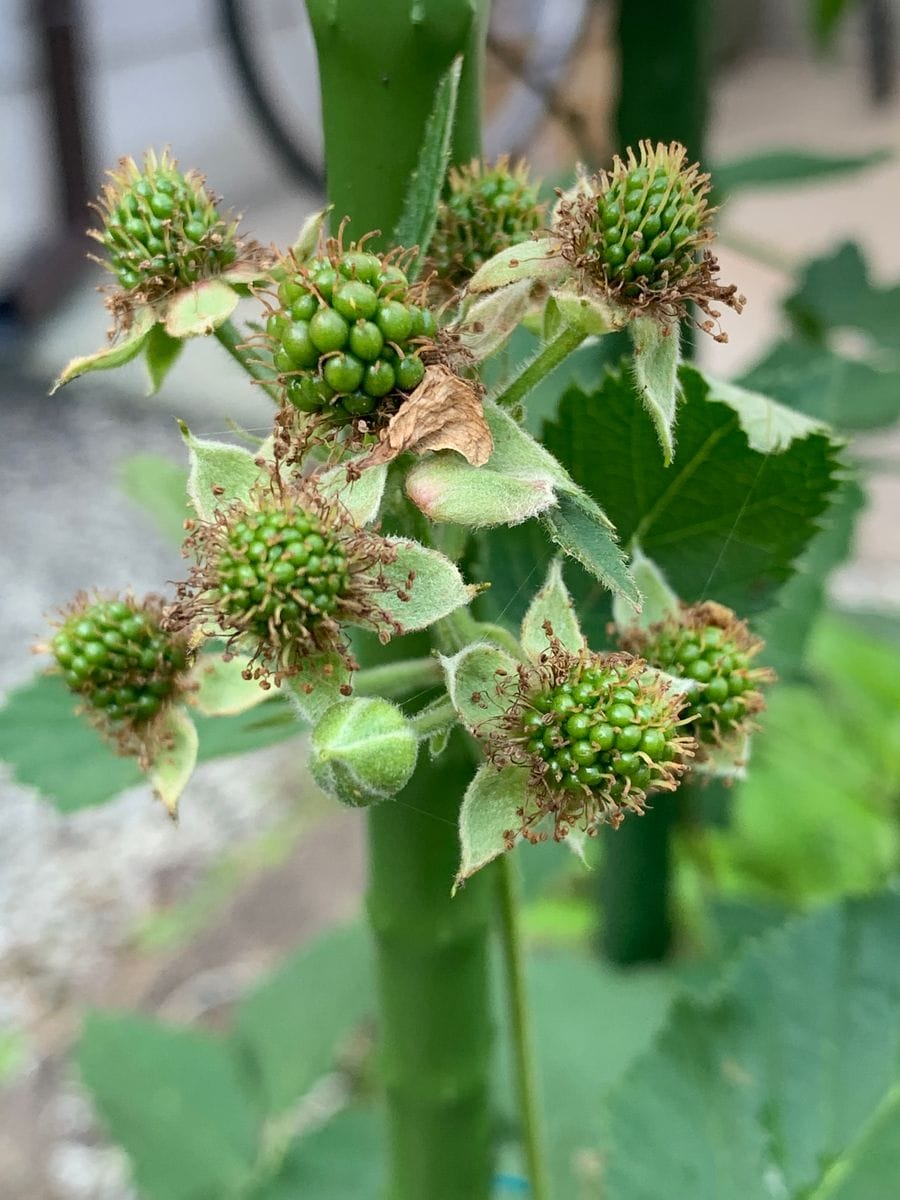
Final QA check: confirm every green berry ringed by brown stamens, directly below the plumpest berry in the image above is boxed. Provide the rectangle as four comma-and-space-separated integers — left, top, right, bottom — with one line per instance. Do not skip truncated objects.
167, 485, 397, 686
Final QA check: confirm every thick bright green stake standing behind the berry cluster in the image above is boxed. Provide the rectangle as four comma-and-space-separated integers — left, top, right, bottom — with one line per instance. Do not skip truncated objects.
307, 0, 493, 1200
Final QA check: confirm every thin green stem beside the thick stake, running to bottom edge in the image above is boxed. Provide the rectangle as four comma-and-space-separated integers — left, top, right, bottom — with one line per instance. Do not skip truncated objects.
494, 854, 550, 1200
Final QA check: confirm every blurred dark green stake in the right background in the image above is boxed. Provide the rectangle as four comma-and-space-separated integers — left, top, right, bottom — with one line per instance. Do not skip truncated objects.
607, 0, 714, 966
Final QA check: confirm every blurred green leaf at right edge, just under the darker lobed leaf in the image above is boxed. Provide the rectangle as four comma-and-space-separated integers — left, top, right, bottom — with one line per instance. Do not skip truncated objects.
739, 338, 900, 432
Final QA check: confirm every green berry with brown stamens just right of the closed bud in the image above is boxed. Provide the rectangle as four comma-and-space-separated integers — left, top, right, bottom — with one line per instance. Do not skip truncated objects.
487, 643, 694, 840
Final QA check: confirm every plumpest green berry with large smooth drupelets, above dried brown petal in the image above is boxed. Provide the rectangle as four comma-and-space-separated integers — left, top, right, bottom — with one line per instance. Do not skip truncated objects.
266, 248, 437, 424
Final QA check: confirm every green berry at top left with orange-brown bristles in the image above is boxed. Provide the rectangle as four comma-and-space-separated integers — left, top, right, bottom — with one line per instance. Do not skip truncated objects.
95, 151, 238, 296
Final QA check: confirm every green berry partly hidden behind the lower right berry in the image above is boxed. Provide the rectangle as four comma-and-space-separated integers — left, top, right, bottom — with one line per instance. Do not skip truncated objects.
620, 602, 774, 755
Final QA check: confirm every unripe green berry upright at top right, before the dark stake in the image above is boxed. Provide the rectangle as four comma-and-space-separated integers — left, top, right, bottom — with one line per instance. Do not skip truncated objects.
595, 142, 708, 296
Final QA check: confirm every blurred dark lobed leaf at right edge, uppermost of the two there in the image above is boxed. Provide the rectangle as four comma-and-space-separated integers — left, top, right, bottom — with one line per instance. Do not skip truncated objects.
785, 242, 900, 353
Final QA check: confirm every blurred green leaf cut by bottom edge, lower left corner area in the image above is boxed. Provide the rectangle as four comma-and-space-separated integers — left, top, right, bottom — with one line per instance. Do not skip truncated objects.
77, 1013, 259, 1200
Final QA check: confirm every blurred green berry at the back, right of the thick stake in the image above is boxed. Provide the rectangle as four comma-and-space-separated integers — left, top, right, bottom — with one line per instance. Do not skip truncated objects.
428, 155, 544, 287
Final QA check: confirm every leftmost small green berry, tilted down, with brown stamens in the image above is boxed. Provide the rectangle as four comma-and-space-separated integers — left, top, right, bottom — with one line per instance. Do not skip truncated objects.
40, 593, 192, 769
